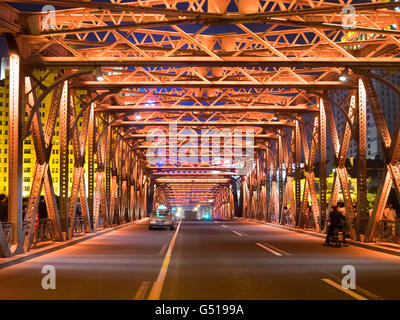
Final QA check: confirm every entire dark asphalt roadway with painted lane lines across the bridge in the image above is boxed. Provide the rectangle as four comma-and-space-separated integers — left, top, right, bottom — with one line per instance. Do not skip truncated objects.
0, 221, 400, 300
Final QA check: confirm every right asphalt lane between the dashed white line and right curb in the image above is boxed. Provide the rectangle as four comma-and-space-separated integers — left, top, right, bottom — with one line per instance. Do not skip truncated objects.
225, 221, 400, 299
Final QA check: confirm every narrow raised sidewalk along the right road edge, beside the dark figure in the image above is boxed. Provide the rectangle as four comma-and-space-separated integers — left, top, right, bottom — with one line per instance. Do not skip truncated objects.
234, 217, 400, 257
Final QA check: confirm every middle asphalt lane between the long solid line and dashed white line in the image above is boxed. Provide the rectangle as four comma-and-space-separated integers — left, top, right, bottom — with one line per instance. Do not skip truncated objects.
161, 221, 352, 300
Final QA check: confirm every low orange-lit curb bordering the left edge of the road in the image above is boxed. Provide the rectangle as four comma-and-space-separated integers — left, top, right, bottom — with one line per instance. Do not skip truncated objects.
0, 219, 148, 270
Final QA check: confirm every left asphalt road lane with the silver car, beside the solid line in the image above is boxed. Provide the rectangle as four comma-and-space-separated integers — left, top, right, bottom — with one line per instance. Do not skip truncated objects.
0, 221, 173, 300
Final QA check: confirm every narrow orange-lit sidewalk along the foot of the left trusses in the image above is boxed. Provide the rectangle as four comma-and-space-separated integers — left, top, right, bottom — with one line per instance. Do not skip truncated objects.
0, 218, 147, 269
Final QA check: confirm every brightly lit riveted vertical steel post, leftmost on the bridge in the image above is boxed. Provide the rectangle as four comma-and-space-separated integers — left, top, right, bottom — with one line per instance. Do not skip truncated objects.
8, 54, 23, 252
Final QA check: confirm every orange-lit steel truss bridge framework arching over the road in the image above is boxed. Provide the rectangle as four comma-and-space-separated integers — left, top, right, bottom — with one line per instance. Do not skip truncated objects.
0, 0, 400, 257
